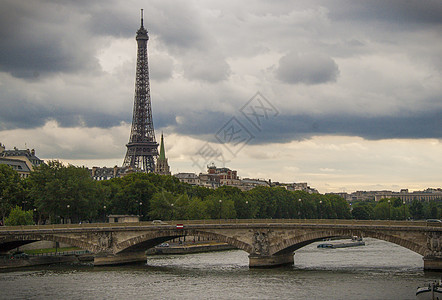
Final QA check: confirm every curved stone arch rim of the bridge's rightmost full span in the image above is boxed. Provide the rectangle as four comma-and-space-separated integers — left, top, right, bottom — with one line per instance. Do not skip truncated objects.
270, 229, 428, 256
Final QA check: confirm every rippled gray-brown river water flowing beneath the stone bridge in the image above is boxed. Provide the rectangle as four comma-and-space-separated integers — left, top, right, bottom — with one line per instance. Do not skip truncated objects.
0, 238, 441, 300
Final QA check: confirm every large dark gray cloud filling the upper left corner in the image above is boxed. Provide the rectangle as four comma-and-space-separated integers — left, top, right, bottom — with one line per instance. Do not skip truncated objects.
0, 0, 98, 79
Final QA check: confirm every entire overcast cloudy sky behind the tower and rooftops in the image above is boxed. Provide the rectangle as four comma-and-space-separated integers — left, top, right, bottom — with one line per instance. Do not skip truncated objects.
0, 0, 442, 193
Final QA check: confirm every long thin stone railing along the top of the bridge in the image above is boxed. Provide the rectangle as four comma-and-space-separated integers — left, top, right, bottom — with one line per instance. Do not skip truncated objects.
0, 219, 442, 232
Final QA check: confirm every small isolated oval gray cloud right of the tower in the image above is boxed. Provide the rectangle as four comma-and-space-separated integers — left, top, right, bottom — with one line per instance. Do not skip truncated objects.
275, 52, 339, 84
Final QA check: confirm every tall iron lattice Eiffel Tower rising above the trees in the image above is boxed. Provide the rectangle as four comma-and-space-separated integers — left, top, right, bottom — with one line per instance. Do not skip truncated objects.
123, 10, 158, 173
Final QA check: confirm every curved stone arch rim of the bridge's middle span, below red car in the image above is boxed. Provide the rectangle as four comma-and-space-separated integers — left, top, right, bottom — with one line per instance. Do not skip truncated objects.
115, 229, 252, 254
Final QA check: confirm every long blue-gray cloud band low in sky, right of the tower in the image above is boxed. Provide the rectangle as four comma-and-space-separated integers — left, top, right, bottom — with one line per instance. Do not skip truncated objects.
167, 110, 442, 144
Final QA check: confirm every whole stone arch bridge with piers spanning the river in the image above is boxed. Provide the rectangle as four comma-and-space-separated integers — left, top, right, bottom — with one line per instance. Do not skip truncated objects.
0, 219, 442, 270
